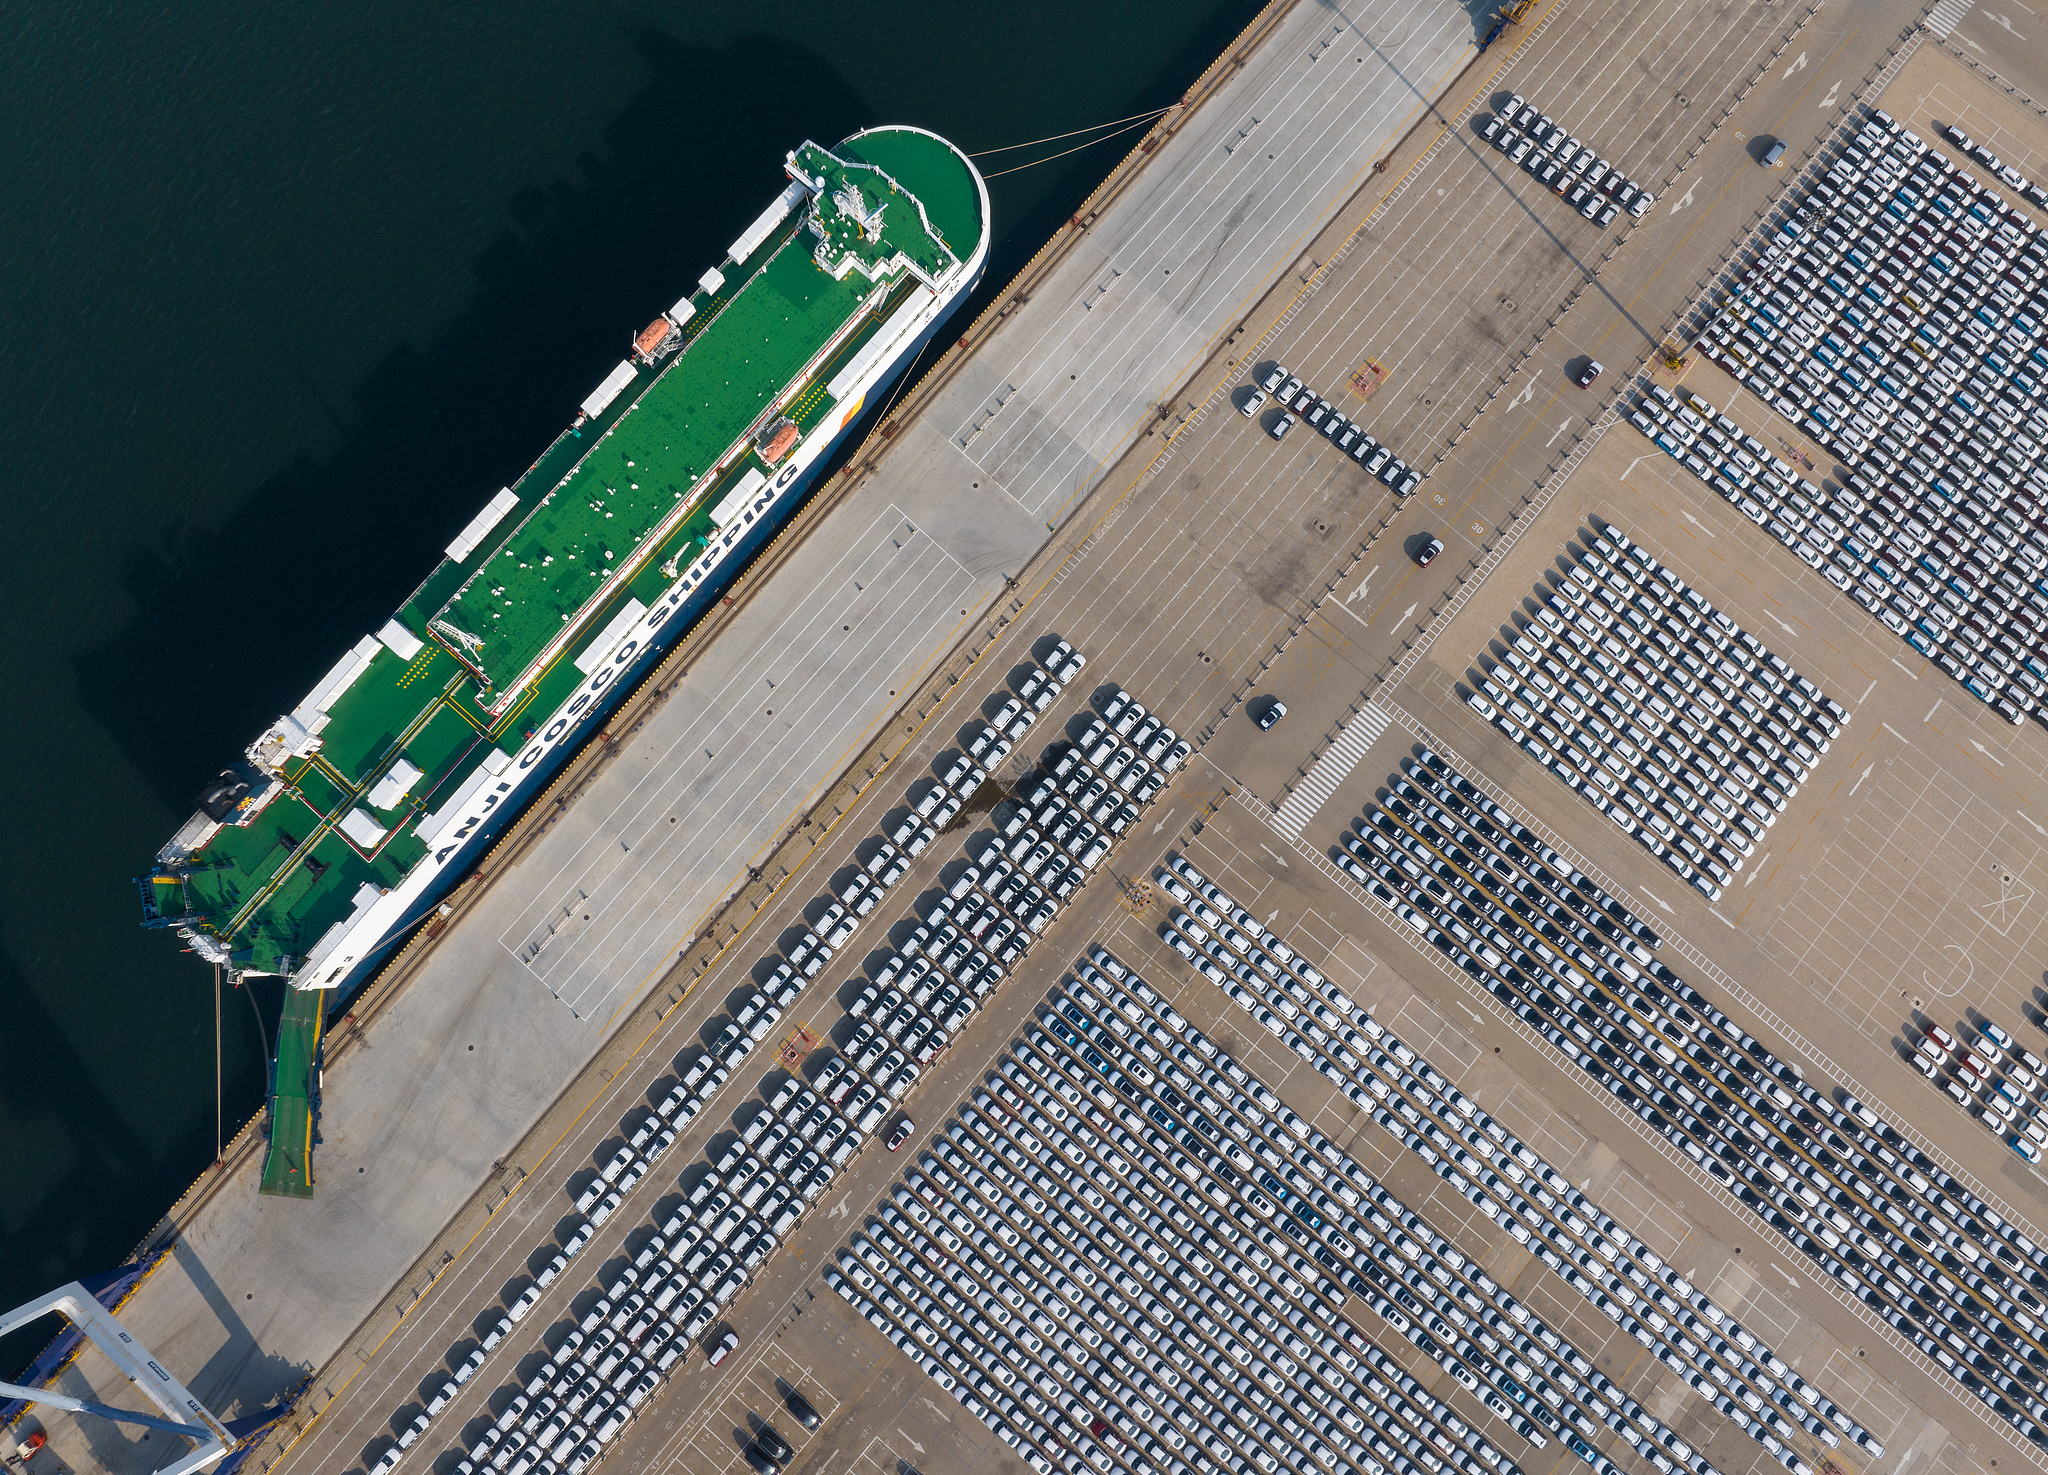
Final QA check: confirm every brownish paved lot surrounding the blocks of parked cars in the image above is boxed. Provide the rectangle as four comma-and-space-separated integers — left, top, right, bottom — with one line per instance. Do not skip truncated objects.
36, 6, 2048, 1475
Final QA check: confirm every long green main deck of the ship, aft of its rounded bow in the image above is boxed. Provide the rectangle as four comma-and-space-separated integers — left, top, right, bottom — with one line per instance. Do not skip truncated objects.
182, 227, 937, 969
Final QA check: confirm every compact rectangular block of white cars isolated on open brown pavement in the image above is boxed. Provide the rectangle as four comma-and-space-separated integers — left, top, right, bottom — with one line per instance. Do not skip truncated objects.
1466, 522, 1849, 901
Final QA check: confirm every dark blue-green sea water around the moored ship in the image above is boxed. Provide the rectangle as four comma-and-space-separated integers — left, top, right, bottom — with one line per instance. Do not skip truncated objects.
0, 0, 1257, 1373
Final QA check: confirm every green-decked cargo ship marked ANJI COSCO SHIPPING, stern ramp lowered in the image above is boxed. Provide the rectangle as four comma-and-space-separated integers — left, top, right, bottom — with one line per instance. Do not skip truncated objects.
137, 127, 989, 1194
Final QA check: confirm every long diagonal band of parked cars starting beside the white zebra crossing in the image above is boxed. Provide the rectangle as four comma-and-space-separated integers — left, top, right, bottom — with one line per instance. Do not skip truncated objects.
1333, 752, 2048, 1448
